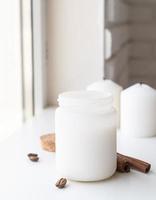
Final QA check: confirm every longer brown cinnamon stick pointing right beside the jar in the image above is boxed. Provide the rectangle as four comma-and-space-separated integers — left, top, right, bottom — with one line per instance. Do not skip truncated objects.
117, 153, 151, 173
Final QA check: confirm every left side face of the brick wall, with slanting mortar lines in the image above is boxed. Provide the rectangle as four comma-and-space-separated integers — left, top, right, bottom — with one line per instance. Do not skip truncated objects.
105, 0, 131, 87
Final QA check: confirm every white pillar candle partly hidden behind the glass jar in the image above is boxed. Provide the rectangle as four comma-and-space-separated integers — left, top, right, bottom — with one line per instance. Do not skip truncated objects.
87, 79, 123, 126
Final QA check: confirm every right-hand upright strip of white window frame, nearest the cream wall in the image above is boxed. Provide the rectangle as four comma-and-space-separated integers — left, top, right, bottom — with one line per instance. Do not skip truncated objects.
31, 0, 47, 115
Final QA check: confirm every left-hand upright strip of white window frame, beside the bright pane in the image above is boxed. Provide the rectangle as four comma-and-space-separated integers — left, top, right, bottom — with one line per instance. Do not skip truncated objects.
20, 0, 34, 121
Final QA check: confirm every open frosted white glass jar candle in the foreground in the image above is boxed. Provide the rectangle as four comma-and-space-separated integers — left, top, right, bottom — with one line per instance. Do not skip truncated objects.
55, 91, 116, 181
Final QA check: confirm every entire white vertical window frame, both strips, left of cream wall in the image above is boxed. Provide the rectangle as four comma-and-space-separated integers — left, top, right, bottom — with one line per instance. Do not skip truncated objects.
20, 0, 47, 121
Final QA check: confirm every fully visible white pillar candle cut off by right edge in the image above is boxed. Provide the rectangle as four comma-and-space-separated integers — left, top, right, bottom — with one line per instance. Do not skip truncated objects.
120, 83, 156, 137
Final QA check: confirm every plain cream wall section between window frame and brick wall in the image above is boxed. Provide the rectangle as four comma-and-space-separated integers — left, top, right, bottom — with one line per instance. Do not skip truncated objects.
47, 0, 104, 104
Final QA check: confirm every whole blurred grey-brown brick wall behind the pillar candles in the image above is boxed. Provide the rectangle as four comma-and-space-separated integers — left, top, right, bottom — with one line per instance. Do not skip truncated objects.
105, 0, 156, 88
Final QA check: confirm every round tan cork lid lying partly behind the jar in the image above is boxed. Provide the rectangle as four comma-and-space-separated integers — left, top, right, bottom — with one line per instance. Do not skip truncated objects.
40, 133, 55, 152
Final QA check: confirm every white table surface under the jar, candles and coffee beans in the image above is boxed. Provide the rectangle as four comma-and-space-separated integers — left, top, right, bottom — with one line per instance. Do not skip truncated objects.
0, 109, 156, 200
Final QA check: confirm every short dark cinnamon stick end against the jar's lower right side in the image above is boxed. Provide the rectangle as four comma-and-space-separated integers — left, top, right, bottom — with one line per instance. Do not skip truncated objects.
116, 156, 130, 173
